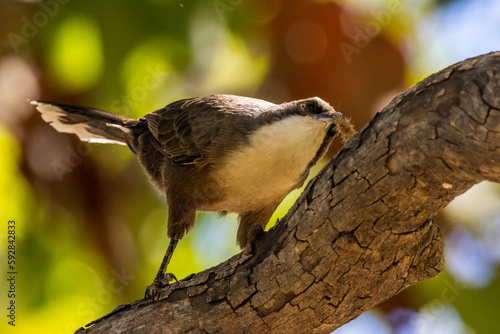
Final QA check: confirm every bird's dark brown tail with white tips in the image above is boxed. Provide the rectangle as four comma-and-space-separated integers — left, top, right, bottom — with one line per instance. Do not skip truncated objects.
30, 101, 137, 145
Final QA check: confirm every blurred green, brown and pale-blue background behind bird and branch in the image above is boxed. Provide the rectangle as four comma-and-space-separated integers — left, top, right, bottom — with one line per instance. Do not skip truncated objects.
0, 0, 500, 334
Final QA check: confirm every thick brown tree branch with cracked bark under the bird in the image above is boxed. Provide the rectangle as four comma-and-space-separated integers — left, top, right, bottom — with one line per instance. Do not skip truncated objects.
77, 53, 500, 333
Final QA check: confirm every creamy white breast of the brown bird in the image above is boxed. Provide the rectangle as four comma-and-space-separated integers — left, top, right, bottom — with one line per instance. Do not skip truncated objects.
214, 116, 328, 213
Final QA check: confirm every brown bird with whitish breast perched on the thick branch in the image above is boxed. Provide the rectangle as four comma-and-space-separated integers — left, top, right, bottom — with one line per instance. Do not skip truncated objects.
30, 94, 342, 300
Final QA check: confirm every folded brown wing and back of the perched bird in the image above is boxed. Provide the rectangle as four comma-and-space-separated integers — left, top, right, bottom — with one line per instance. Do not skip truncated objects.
144, 95, 273, 165
